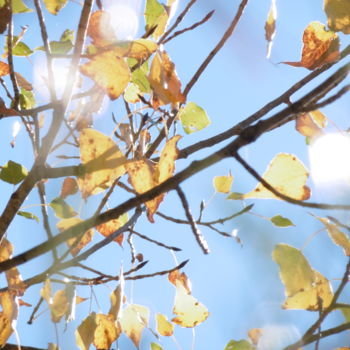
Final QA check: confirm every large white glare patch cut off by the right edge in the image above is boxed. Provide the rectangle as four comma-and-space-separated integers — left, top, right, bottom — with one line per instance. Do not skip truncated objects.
309, 133, 350, 184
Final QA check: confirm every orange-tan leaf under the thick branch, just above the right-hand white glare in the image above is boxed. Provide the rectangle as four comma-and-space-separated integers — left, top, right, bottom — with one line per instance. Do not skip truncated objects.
295, 110, 327, 138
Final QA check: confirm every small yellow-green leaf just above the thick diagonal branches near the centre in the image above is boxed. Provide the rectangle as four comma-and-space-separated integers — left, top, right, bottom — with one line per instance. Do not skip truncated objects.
179, 102, 210, 134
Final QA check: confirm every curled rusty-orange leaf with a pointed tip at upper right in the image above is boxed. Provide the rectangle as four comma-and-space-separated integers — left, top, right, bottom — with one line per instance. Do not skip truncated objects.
283, 22, 340, 70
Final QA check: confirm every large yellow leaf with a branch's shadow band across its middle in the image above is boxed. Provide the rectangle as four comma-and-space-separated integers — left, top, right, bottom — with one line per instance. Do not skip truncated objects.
78, 129, 126, 199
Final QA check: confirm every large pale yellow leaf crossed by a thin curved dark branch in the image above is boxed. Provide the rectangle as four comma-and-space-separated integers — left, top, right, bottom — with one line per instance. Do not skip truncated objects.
243, 153, 310, 200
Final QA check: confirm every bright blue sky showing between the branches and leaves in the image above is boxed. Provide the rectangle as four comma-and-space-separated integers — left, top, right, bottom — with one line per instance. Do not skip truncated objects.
0, 0, 350, 350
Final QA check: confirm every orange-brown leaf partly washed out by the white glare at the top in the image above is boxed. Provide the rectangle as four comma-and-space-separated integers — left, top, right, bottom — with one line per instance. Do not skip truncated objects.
87, 11, 117, 47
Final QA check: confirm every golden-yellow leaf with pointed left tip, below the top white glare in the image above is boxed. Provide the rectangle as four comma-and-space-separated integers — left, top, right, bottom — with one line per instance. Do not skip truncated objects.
80, 50, 131, 100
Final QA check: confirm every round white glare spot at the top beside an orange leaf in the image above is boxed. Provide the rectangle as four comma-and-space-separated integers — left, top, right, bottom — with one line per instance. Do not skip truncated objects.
106, 1, 139, 40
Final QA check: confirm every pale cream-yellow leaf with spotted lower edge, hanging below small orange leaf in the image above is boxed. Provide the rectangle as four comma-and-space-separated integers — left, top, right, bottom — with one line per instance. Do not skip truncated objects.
172, 281, 209, 328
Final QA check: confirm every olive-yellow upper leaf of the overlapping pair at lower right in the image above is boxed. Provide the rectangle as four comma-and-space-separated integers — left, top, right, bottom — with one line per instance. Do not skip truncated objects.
272, 244, 314, 296
